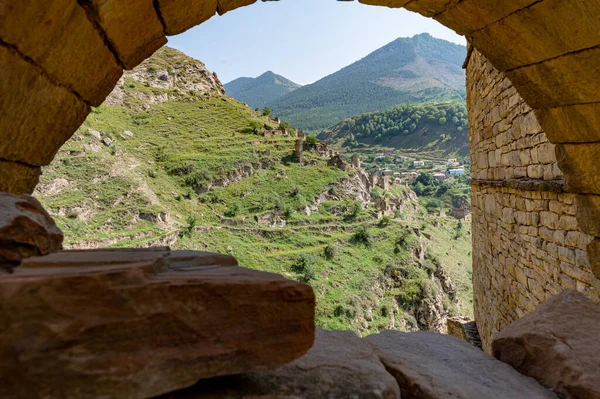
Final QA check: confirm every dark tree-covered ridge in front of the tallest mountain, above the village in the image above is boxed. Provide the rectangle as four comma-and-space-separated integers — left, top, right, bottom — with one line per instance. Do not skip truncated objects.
319, 101, 469, 156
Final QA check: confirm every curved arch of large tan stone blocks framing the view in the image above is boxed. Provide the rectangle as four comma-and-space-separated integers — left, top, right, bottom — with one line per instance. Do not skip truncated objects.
0, 0, 600, 346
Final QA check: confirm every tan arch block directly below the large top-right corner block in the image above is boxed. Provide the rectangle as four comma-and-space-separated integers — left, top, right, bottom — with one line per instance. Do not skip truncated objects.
506, 47, 600, 109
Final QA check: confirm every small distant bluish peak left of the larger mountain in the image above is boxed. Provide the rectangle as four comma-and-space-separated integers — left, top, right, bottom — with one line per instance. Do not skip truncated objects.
225, 71, 302, 109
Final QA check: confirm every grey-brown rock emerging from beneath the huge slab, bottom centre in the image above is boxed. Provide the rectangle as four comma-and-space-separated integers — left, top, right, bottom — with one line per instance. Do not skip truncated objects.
161, 329, 400, 399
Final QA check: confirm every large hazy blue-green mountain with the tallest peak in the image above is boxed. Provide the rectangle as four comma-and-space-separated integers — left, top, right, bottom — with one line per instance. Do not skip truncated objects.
267, 34, 466, 131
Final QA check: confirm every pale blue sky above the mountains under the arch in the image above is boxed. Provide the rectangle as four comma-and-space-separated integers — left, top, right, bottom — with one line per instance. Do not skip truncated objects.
168, 0, 465, 84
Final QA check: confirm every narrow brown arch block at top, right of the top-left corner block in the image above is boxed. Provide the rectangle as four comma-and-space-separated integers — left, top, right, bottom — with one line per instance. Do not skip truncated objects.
81, 0, 166, 69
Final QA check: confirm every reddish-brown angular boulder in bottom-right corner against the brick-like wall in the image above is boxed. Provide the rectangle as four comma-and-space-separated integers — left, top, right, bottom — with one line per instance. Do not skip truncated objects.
493, 290, 600, 398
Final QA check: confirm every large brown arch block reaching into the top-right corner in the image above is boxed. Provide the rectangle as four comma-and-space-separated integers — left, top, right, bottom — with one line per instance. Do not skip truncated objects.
468, 0, 600, 71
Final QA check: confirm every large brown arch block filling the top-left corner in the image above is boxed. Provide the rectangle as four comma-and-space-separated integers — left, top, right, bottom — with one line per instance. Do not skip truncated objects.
0, 0, 123, 105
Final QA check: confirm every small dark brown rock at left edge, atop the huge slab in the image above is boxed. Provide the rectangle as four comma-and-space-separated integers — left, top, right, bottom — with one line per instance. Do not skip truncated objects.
0, 193, 63, 272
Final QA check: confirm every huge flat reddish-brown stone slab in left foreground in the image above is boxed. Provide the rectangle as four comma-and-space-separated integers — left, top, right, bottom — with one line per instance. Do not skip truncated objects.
0, 249, 314, 399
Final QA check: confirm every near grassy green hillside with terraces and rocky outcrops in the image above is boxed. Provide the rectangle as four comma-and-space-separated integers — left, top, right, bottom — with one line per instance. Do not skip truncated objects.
36, 49, 472, 334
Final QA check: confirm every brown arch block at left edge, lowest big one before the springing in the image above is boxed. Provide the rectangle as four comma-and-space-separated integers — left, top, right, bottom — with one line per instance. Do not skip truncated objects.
0, 44, 89, 166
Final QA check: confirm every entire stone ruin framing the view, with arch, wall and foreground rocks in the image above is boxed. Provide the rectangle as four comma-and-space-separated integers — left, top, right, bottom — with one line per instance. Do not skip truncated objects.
0, 0, 600, 398
